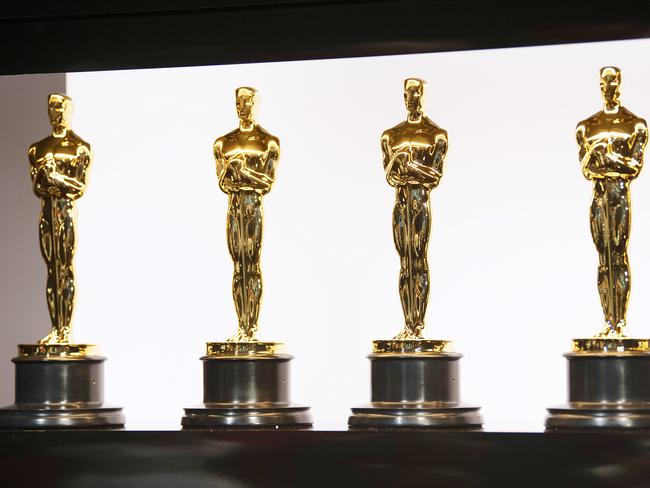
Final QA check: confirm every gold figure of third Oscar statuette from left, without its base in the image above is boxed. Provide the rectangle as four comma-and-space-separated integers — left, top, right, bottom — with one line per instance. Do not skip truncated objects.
376, 78, 448, 349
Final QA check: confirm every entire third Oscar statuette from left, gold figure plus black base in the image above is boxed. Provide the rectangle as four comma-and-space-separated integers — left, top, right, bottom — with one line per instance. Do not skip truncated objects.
348, 78, 483, 430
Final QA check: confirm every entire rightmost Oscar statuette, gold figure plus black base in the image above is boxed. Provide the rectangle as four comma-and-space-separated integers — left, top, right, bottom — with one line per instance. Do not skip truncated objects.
546, 66, 650, 430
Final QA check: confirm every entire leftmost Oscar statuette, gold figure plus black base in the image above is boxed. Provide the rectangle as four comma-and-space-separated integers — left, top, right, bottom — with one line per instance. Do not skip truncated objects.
0, 93, 124, 429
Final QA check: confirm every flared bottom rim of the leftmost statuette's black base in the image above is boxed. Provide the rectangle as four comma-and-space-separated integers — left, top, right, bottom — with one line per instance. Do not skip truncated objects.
0, 405, 125, 430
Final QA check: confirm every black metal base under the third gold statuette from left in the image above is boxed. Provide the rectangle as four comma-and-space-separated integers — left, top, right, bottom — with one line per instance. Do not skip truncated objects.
348, 353, 483, 430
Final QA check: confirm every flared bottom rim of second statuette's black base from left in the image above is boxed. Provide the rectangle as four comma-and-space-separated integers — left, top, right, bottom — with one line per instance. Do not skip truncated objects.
181, 404, 313, 430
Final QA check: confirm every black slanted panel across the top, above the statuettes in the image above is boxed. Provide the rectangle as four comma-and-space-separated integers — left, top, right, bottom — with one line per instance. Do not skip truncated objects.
0, 0, 650, 74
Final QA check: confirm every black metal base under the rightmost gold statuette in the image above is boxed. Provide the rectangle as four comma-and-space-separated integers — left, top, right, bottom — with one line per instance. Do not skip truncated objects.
546, 353, 650, 430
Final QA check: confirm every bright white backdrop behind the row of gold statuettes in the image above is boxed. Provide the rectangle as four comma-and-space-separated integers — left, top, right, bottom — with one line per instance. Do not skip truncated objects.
64, 41, 650, 431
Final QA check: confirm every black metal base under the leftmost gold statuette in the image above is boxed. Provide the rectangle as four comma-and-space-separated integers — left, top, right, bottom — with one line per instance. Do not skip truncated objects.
0, 356, 124, 430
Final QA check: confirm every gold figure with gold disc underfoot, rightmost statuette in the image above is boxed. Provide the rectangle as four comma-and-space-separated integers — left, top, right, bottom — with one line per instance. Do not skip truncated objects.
573, 66, 650, 352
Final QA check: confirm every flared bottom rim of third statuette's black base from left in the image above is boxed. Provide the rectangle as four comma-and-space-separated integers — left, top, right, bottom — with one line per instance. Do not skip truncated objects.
348, 403, 483, 430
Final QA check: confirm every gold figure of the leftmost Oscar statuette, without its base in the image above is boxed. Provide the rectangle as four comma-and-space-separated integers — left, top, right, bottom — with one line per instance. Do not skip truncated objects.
28, 93, 91, 349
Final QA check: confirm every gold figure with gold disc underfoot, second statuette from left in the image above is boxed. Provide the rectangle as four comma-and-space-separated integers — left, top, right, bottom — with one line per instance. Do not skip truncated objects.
207, 87, 282, 356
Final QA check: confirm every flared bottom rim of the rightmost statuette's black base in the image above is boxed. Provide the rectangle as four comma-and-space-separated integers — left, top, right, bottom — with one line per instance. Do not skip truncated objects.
546, 403, 650, 430
